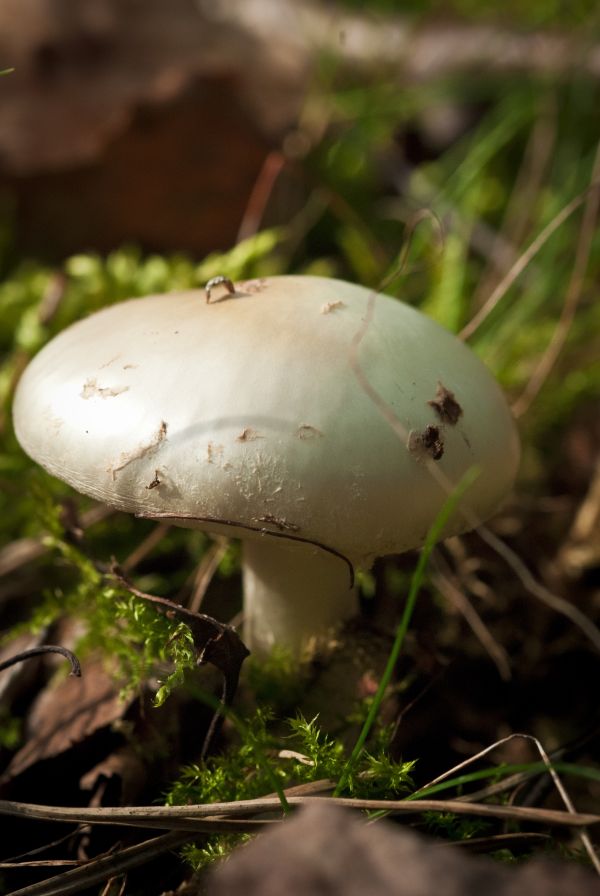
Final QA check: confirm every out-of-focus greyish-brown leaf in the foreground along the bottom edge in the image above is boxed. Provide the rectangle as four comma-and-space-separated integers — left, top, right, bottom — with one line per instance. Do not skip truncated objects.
210, 802, 600, 896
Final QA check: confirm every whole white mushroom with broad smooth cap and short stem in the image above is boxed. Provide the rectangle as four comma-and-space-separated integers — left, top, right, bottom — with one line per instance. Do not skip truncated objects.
14, 276, 519, 657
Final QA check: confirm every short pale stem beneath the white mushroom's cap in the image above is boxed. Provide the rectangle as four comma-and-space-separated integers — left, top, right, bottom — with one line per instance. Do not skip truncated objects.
243, 537, 358, 659
